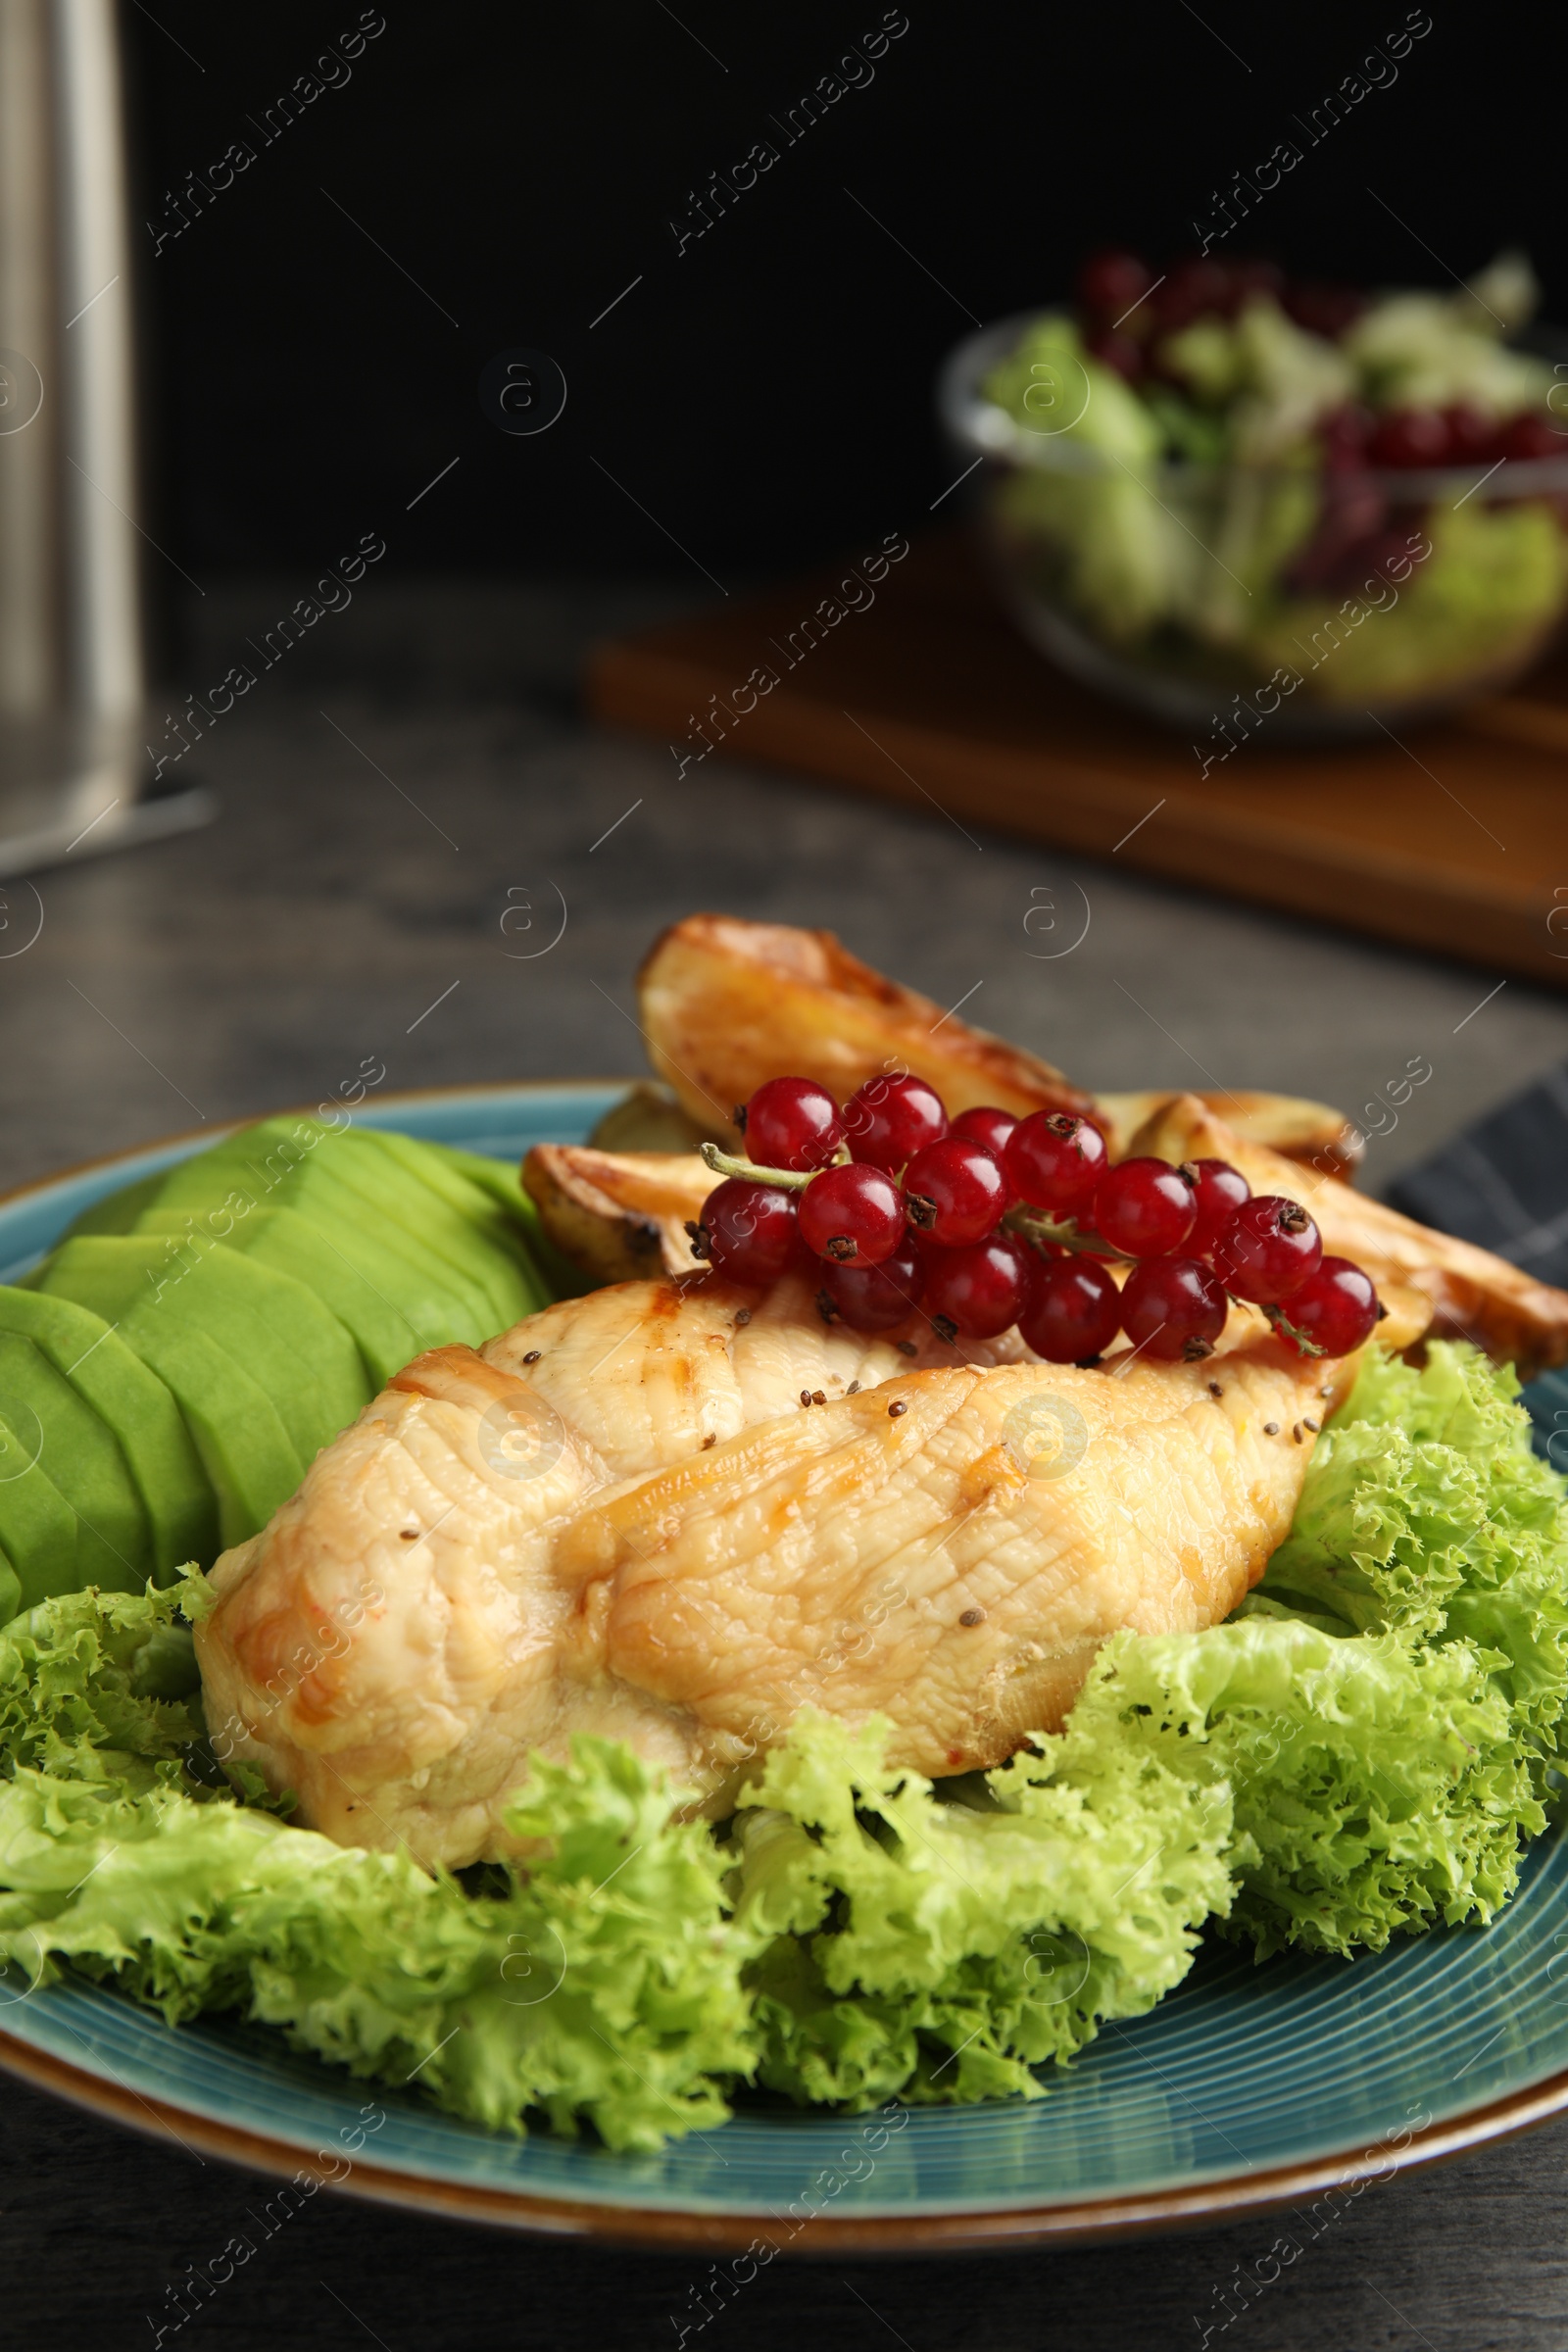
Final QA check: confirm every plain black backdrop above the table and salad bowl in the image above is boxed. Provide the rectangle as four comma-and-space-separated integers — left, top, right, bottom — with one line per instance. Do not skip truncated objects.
127, 0, 1568, 590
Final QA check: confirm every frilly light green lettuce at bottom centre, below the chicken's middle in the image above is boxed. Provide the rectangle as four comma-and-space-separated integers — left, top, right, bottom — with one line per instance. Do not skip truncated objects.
736, 1717, 1230, 2107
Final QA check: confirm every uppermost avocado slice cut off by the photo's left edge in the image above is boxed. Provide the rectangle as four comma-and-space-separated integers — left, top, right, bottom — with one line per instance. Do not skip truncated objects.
0, 1287, 219, 1588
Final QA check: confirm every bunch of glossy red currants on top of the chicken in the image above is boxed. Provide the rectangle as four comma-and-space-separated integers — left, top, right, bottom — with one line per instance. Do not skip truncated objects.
689, 1075, 1382, 1364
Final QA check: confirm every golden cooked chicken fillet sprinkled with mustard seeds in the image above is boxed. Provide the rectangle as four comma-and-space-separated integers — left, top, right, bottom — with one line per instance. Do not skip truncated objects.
195, 1277, 1354, 1868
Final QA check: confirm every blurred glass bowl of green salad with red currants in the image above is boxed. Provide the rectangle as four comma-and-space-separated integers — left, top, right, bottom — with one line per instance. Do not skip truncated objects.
938, 252, 1568, 738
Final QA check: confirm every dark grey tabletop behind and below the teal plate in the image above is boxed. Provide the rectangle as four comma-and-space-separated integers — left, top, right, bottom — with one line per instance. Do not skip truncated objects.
0, 581, 1568, 2352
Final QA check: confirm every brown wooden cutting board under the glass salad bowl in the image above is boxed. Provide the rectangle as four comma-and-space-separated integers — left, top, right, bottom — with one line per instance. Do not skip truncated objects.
588, 536, 1568, 988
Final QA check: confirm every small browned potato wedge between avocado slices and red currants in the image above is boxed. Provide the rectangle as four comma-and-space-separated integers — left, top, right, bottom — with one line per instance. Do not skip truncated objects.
522, 1143, 714, 1282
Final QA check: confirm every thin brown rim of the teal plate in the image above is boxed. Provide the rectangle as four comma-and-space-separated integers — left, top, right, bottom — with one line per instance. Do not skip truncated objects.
0, 1075, 1568, 2260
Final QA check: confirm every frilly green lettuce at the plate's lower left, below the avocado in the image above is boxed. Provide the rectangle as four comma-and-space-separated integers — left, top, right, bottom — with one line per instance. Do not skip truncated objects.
0, 1592, 755, 2147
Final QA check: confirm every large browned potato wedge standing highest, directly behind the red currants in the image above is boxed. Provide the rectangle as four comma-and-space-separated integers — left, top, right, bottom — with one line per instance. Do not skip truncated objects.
637, 915, 1091, 1139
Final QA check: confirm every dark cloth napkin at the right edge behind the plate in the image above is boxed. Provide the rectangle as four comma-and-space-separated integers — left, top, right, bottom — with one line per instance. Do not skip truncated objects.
1390, 1063, 1568, 1289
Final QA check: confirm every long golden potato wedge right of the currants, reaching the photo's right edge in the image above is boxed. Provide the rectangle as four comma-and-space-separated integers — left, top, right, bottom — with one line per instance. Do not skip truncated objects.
1131, 1094, 1568, 1381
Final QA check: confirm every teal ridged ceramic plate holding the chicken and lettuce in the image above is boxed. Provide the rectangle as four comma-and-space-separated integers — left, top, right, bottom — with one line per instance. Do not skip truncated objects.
0, 1084, 1568, 2238
